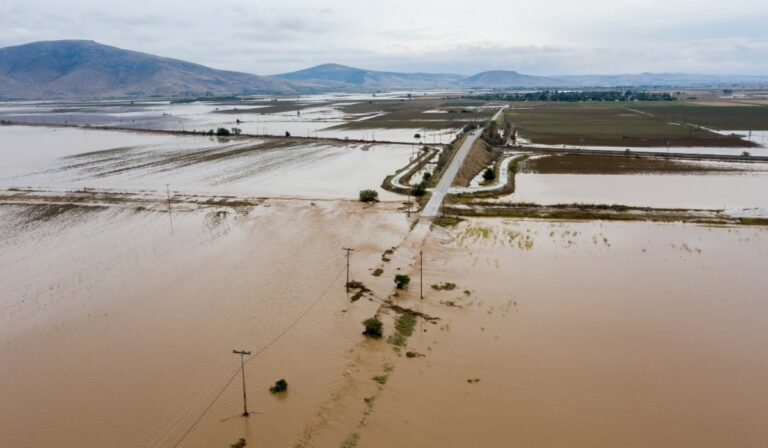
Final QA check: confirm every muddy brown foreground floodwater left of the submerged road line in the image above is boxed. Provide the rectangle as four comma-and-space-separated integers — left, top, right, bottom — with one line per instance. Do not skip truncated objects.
0, 201, 408, 448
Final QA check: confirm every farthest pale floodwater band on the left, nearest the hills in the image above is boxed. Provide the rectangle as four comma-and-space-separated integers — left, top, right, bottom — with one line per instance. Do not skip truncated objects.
0, 92, 457, 144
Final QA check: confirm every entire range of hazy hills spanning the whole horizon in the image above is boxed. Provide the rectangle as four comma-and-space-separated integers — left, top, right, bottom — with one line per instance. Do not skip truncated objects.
0, 40, 768, 99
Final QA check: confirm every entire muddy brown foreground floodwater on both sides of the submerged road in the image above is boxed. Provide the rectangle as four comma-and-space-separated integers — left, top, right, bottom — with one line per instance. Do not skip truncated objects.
6, 201, 768, 447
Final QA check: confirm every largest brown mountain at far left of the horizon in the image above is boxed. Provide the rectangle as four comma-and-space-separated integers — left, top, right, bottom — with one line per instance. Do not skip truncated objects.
0, 40, 302, 99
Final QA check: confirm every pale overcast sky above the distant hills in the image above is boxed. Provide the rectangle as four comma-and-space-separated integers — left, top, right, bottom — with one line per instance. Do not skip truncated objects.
0, 0, 768, 75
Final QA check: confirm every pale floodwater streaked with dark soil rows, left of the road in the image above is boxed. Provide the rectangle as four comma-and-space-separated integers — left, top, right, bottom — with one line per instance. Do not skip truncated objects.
0, 126, 413, 199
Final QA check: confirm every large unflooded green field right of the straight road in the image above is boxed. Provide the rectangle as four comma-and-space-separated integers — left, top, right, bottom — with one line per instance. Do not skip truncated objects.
505, 102, 753, 147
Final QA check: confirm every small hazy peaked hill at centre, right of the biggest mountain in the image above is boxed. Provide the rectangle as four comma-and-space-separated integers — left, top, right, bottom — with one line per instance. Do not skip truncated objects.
274, 64, 465, 90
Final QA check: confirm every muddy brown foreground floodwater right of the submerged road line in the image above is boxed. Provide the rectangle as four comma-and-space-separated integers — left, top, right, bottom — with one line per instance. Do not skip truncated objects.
356, 219, 768, 448
